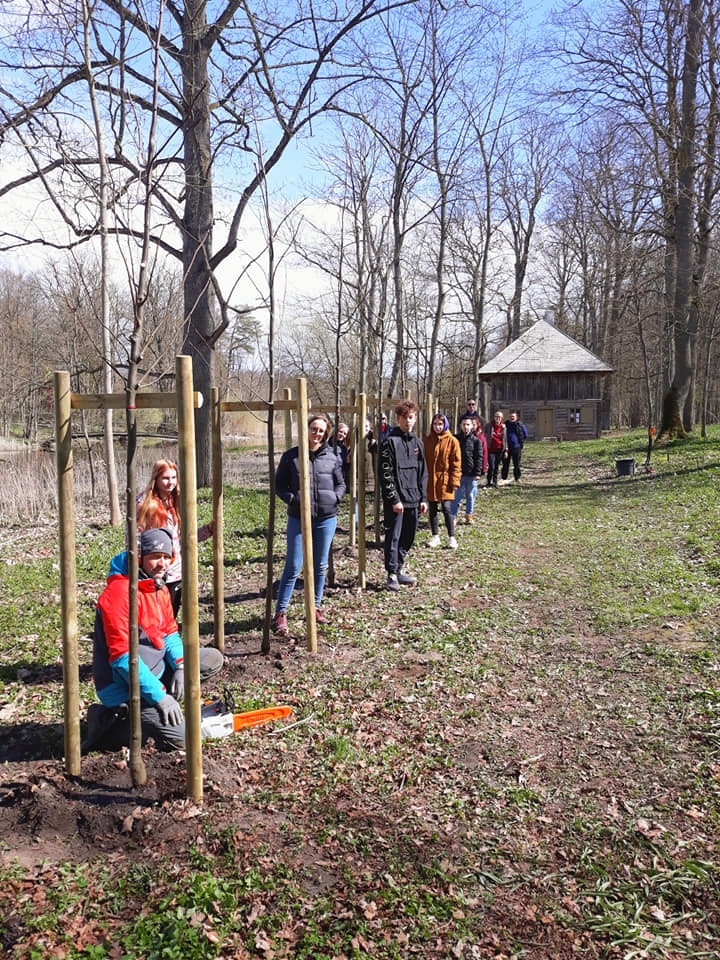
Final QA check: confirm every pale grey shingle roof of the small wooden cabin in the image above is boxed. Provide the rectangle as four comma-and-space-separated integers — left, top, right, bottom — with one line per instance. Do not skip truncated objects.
480, 320, 612, 377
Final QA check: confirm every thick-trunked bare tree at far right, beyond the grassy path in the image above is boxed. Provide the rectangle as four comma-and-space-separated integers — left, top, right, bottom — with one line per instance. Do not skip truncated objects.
557, 0, 718, 436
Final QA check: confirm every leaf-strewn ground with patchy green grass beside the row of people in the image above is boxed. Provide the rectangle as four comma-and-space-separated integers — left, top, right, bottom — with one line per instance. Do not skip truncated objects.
0, 436, 720, 960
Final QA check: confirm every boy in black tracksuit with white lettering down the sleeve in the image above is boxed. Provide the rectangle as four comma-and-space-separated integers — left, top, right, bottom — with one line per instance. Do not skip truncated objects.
380, 400, 427, 591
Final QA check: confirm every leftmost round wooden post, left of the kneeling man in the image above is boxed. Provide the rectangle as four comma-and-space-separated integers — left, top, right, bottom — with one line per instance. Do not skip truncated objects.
55, 370, 80, 777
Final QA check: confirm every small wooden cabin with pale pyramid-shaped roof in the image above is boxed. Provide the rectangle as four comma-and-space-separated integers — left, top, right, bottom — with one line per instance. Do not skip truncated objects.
480, 320, 612, 440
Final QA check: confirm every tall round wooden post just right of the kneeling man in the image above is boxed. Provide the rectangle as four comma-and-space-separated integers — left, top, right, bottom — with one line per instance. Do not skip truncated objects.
175, 356, 203, 803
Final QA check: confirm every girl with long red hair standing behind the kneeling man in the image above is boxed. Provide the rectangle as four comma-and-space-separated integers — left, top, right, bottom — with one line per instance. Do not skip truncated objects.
137, 460, 214, 617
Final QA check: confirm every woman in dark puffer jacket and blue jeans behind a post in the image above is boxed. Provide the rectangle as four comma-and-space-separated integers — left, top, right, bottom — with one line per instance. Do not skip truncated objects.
274, 413, 345, 636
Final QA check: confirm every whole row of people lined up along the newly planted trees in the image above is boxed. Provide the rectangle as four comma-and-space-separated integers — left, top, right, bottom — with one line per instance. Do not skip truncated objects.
86, 400, 527, 750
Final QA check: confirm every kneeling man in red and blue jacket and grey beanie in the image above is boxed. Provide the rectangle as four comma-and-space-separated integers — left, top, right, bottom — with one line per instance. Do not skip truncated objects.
86, 528, 223, 750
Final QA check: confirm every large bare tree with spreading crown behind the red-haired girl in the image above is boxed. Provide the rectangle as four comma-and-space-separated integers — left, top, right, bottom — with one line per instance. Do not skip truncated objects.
0, 0, 413, 485
